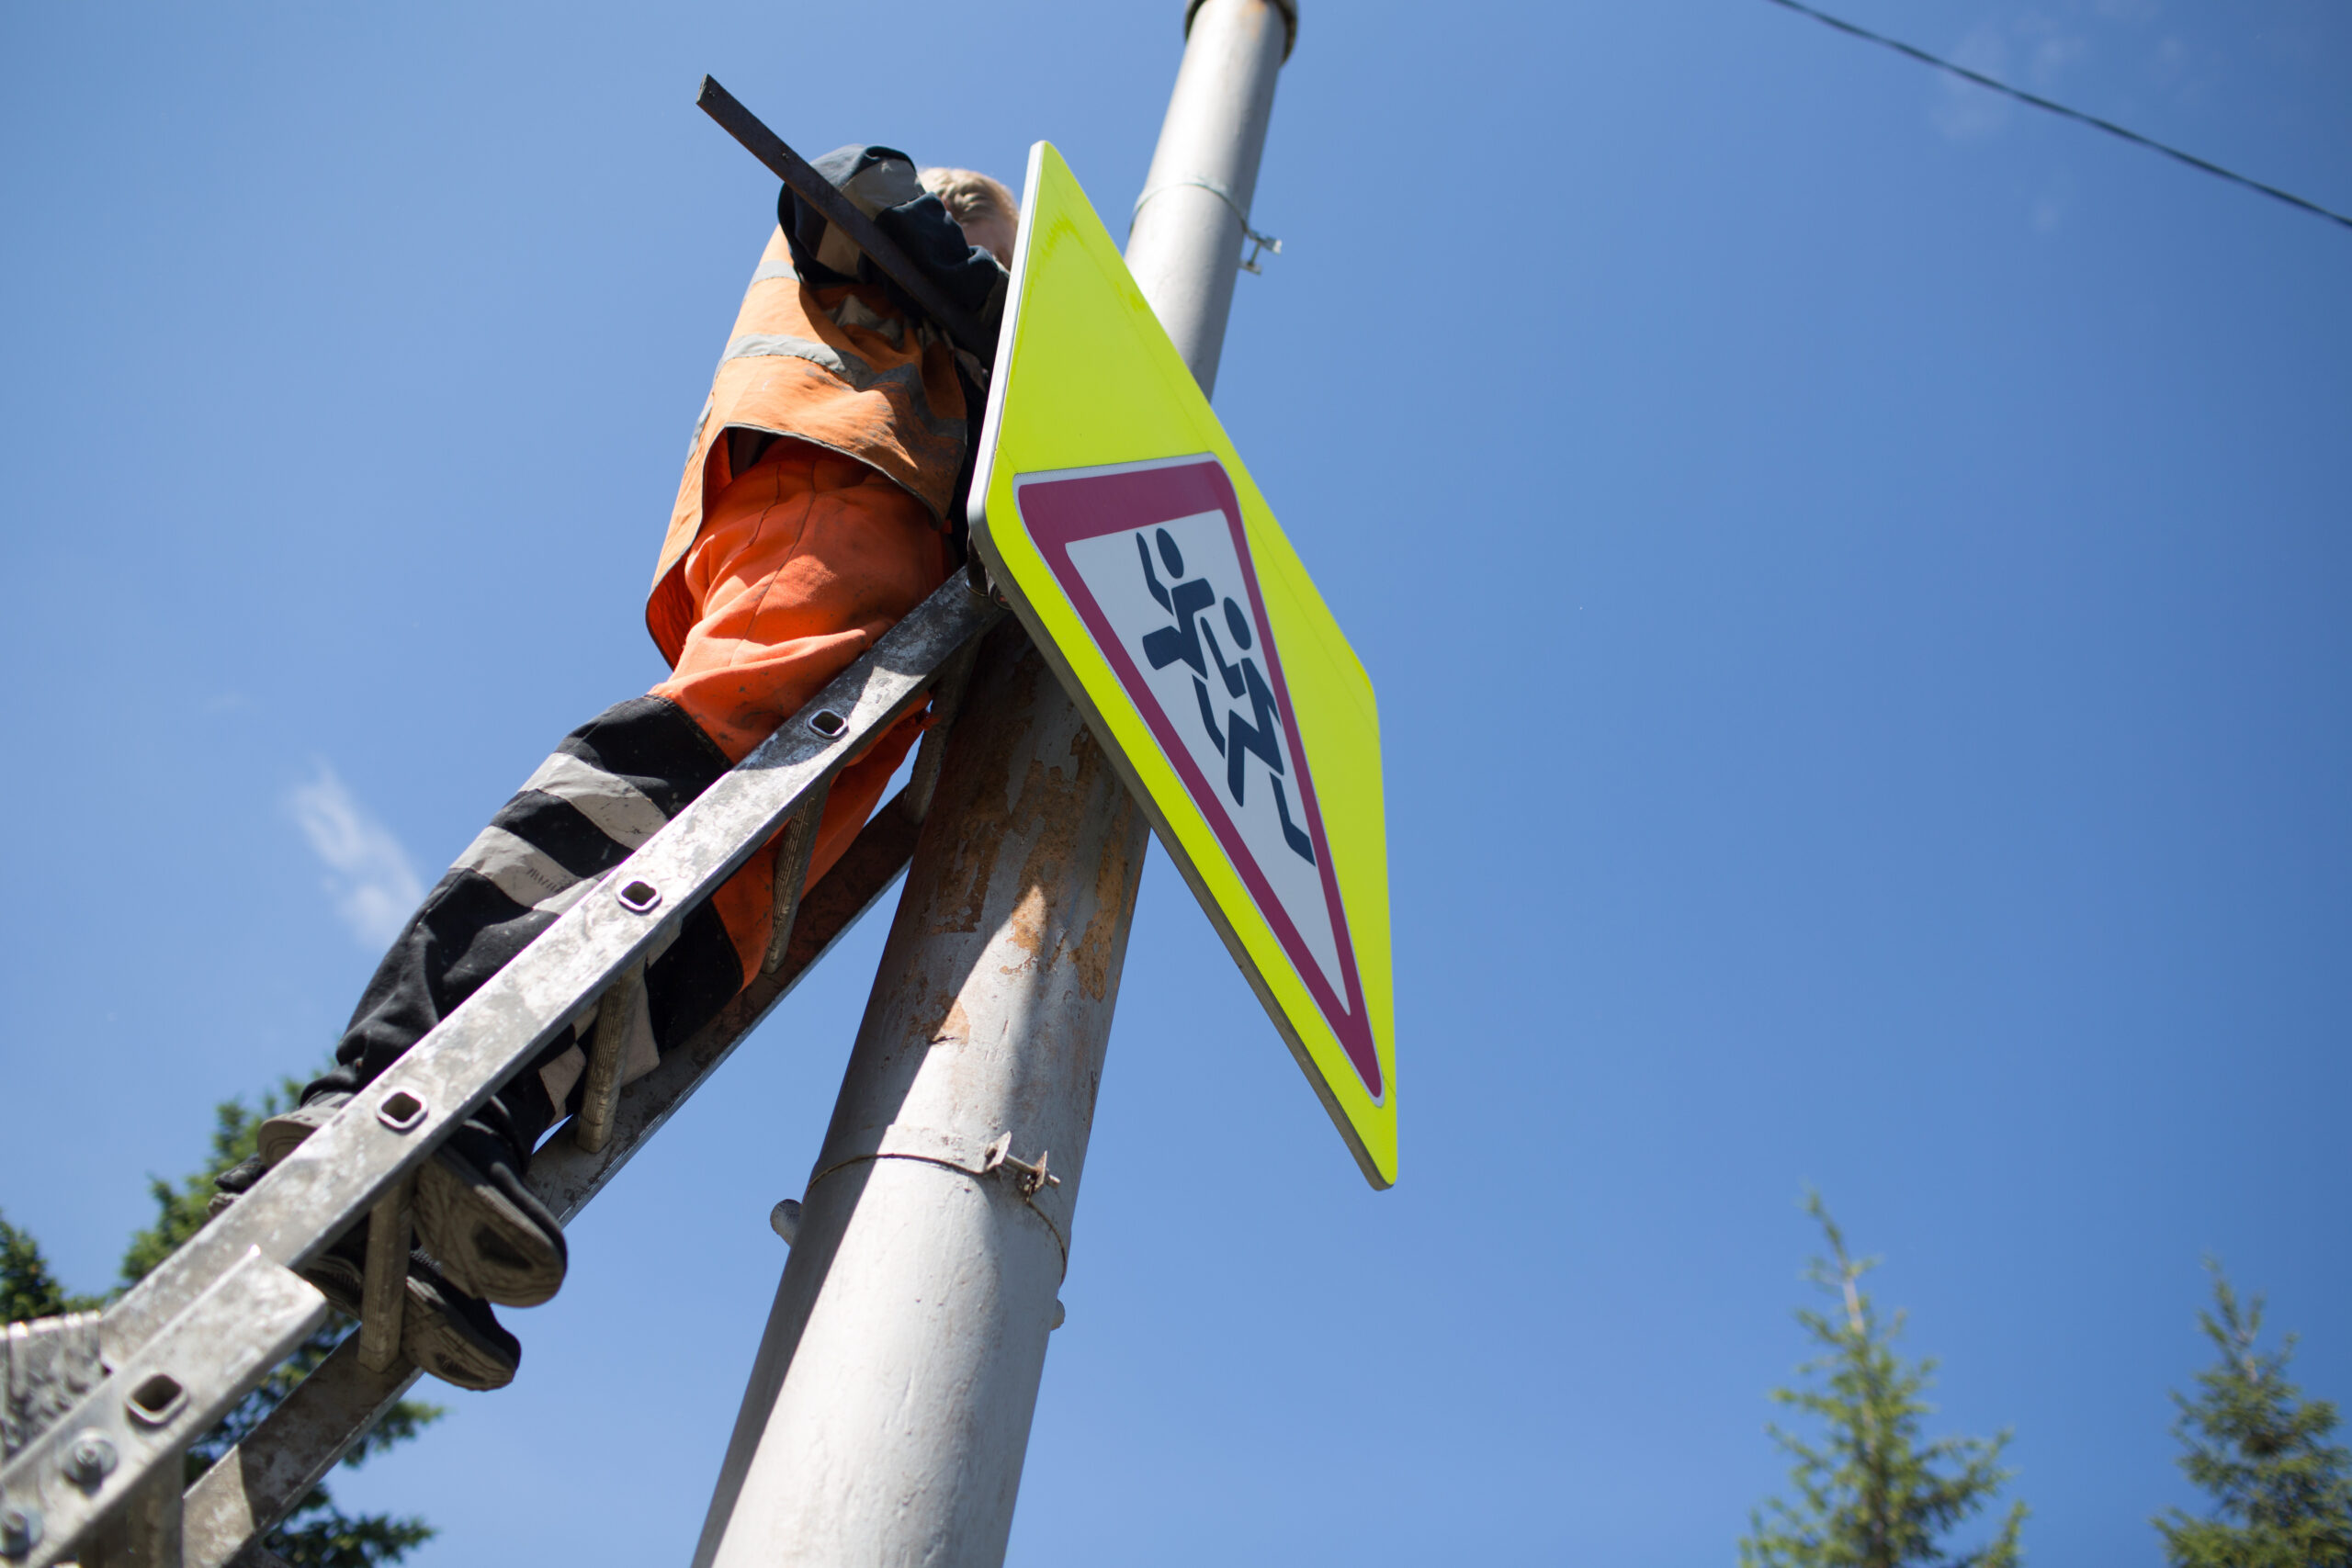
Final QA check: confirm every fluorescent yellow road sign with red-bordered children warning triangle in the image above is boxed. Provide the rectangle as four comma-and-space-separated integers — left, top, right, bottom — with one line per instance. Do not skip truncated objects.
971, 141, 1397, 1187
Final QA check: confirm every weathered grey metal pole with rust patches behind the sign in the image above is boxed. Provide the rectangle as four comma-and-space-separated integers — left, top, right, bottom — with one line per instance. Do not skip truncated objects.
694, 0, 1296, 1568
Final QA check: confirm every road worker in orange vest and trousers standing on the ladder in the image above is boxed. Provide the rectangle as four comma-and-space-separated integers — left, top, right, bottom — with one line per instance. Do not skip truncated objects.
221, 146, 1018, 1389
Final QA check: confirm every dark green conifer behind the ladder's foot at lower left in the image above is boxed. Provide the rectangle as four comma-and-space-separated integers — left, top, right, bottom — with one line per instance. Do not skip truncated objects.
0, 1084, 440, 1568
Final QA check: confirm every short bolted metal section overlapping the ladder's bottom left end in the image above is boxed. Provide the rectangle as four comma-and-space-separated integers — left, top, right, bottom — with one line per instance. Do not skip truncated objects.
5, 1248, 327, 1568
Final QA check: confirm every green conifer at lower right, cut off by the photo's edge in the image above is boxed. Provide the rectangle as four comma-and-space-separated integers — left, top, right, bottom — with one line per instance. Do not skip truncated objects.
2154, 1260, 2352, 1568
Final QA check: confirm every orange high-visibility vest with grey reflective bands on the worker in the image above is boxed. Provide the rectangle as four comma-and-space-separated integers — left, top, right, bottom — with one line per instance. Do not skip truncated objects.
644, 228, 967, 665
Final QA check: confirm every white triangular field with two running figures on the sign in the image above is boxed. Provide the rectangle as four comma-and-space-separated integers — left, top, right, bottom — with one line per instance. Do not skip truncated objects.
1070, 513, 1348, 997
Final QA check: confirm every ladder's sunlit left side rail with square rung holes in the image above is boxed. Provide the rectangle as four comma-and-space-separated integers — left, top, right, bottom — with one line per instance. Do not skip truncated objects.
0, 573, 1002, 1556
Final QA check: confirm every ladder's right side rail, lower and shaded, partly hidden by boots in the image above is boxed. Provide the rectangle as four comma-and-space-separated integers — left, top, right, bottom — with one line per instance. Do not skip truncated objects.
170, 700, 953, 1568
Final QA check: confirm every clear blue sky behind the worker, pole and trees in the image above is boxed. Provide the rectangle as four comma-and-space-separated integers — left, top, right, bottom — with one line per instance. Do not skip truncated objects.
0, 0, 2352, 1568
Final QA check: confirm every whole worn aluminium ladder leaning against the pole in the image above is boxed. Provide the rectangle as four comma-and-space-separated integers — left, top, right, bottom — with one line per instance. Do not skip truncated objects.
0, 573, 1004, 1568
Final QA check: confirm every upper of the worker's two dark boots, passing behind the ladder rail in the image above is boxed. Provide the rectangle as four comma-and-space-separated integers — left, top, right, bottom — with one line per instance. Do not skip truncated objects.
259, 1090, 567, 1307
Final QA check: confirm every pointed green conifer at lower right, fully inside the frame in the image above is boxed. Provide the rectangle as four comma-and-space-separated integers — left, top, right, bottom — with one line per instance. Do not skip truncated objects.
1740, 1192, 2025, 1568
